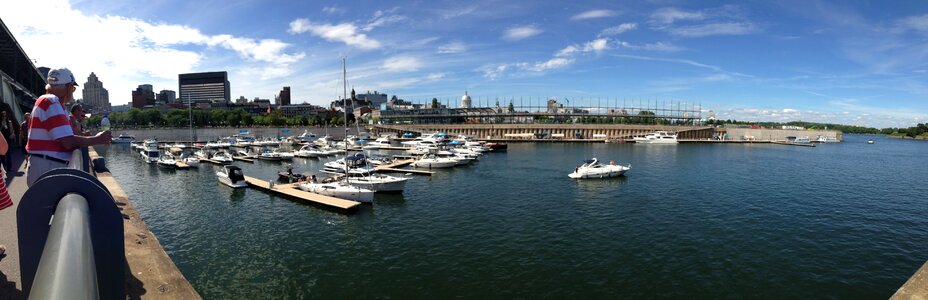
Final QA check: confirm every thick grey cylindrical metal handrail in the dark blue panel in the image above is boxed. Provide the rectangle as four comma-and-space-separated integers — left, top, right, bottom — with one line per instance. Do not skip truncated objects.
29, 193, 100, 299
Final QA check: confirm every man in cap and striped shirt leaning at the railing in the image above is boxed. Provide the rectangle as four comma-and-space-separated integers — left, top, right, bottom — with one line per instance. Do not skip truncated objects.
26, 68, 112, 187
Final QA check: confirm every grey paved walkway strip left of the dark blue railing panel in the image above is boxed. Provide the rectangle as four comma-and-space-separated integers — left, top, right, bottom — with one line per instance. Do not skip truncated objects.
0, 148, 26, 299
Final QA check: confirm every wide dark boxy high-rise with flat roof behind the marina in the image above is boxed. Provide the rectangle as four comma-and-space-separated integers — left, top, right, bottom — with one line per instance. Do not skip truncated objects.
177, 71, 231, 103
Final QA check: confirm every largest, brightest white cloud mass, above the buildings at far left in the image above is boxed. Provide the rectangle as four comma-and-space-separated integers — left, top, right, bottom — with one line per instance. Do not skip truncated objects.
0, 0, 305, 105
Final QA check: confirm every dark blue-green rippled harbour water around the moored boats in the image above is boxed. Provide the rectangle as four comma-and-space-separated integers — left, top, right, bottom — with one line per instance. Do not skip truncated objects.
106, 136, 928, 299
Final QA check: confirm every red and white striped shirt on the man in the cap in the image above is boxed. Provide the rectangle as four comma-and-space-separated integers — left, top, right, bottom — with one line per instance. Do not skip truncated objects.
26, 94, 74, 160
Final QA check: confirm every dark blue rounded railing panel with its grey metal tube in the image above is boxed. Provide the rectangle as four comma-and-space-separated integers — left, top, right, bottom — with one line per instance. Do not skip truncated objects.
16, 156, 125, 299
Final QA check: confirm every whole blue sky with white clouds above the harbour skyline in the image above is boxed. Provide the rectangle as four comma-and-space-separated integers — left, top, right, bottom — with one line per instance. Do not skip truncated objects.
0, 0, 928, 127
